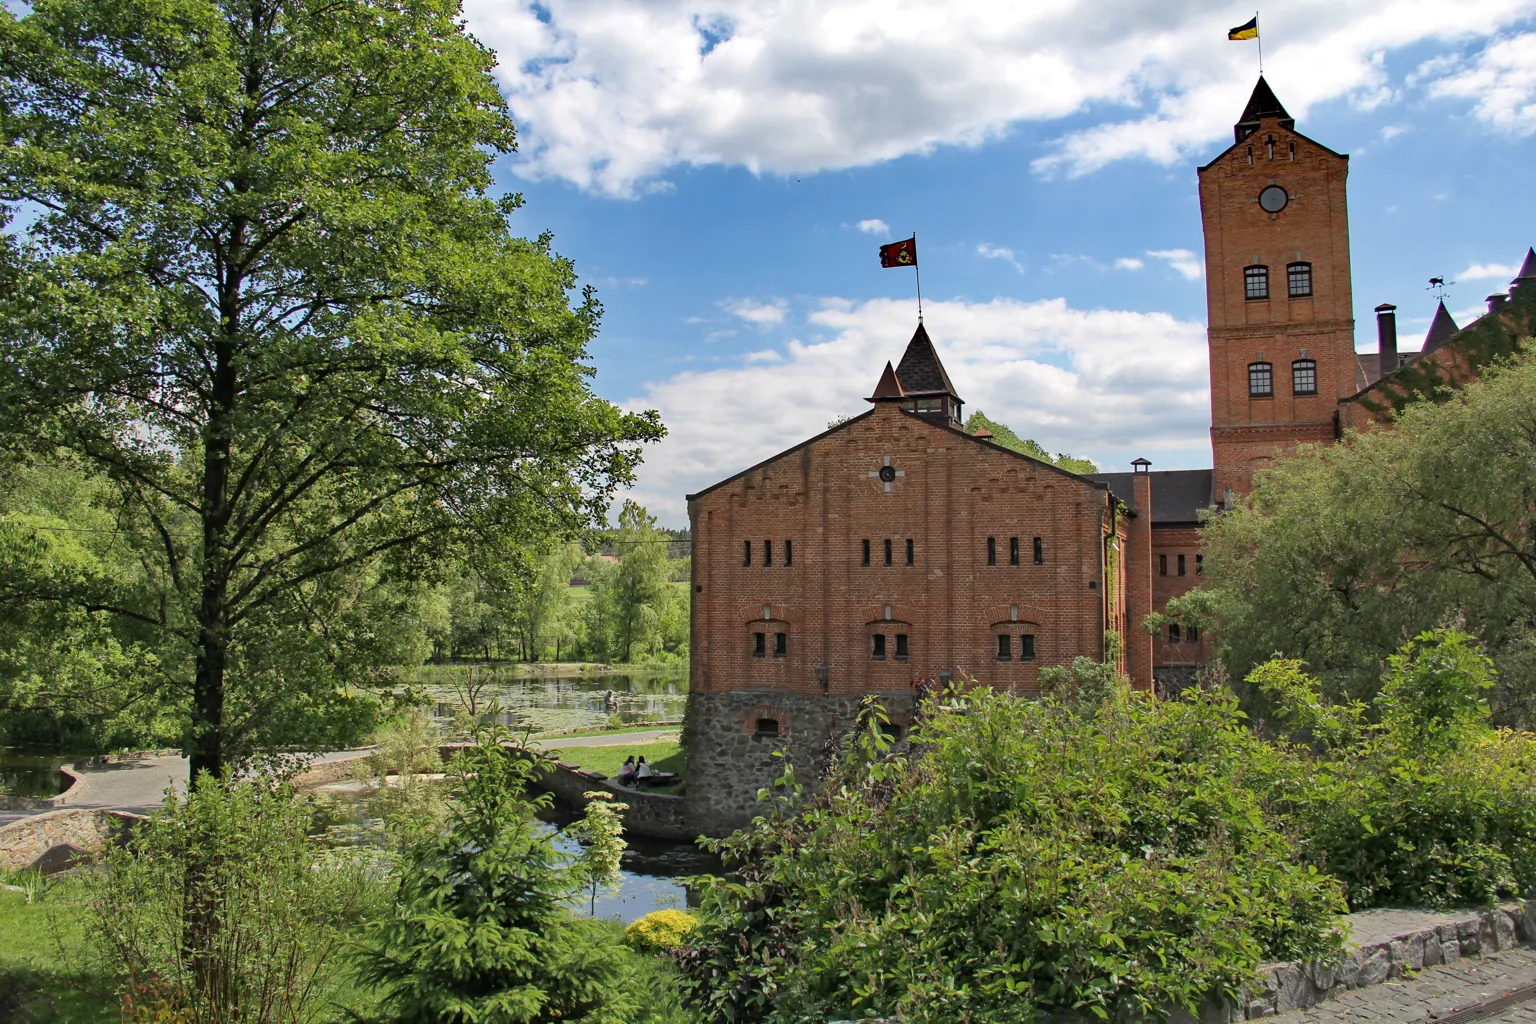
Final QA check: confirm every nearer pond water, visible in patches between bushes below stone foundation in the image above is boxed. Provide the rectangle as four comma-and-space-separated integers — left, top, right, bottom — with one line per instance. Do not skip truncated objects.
315, 781, 720, 924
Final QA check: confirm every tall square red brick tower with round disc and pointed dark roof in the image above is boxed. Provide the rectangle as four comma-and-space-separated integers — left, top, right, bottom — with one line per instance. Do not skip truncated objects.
1200, 77, 1359, 502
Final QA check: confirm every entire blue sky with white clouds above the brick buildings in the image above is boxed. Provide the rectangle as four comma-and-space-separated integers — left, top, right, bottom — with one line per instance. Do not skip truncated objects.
465, 0, 1536, 525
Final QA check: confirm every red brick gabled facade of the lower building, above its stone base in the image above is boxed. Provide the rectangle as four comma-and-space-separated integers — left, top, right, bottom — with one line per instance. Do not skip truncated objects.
688, 401, 1127, 703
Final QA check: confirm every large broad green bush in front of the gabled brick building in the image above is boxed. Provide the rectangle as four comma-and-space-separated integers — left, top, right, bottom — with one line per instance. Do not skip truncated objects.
679, 672, 1344, 1024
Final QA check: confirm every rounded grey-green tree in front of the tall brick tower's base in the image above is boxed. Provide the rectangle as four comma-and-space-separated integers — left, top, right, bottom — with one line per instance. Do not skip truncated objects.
1169, 340, 1536, 722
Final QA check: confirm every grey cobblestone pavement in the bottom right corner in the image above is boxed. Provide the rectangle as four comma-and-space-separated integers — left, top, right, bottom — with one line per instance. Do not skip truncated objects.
1270, 946, 1536, 1024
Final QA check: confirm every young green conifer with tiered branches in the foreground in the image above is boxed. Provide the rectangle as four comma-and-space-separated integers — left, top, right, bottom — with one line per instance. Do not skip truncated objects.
361, 729, 672, 1024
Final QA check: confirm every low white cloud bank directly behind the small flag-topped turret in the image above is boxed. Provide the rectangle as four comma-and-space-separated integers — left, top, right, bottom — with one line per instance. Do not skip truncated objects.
625, 299, 1210, 524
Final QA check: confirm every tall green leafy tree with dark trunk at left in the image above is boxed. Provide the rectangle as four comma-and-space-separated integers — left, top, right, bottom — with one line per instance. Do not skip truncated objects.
0, 0, 662, 778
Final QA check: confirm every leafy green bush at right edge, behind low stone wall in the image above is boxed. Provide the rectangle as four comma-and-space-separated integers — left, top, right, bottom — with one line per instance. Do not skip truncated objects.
1249, 629, 1536, 910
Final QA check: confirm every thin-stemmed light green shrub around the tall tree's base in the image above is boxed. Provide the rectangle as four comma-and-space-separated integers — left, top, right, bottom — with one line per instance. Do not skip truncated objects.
88, 775, 376, 1024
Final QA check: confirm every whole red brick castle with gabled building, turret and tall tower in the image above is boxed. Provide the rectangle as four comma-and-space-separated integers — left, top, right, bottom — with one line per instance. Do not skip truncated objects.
685, 78, 1536, 834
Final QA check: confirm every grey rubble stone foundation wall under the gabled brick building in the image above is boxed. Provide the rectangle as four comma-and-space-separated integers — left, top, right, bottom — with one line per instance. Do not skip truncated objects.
682, 689, 912, 837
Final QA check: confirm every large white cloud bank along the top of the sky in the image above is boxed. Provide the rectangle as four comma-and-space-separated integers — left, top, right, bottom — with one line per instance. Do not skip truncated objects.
465, 0, 1536, 195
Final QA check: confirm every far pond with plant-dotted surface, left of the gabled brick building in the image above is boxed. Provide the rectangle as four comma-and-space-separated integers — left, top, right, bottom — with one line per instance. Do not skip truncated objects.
399, 663, 688, 732
